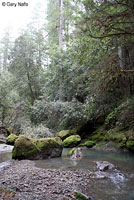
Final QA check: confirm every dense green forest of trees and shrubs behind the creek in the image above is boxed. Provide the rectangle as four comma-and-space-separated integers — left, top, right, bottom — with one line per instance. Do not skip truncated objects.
0, 0, 134, 137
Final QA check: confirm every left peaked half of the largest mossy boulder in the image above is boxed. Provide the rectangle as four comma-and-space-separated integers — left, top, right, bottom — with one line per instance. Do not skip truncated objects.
12, 136, 39, 159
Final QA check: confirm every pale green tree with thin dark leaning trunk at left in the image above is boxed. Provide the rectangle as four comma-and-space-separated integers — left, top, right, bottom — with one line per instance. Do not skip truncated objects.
10, 33, 41, 105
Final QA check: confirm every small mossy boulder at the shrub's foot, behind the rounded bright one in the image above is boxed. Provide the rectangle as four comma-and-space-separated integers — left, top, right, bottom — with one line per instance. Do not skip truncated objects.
57, 129, 77, 140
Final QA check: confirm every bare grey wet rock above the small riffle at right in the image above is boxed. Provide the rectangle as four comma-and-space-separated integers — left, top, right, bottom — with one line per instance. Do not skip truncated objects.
96, 161, 114, 171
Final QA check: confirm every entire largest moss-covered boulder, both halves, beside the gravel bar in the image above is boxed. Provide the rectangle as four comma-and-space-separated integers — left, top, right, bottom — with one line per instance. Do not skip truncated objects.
12, 136, 63, 160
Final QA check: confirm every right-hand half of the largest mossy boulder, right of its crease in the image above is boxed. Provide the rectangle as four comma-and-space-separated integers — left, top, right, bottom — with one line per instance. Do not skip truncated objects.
36, 137, 63, 159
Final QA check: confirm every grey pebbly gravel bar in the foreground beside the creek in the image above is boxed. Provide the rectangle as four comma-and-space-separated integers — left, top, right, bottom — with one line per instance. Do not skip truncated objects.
0, 160, 91, 200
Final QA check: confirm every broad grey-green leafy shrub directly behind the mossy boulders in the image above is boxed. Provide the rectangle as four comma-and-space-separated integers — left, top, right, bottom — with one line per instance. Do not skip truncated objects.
31, 100, 89, 131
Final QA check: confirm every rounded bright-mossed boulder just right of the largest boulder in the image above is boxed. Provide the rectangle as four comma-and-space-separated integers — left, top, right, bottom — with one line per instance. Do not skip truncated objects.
63, 135, 81, 148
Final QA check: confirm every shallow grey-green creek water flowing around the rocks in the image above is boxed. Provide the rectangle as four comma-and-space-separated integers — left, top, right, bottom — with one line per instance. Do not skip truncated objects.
0, 149, 134, 200
